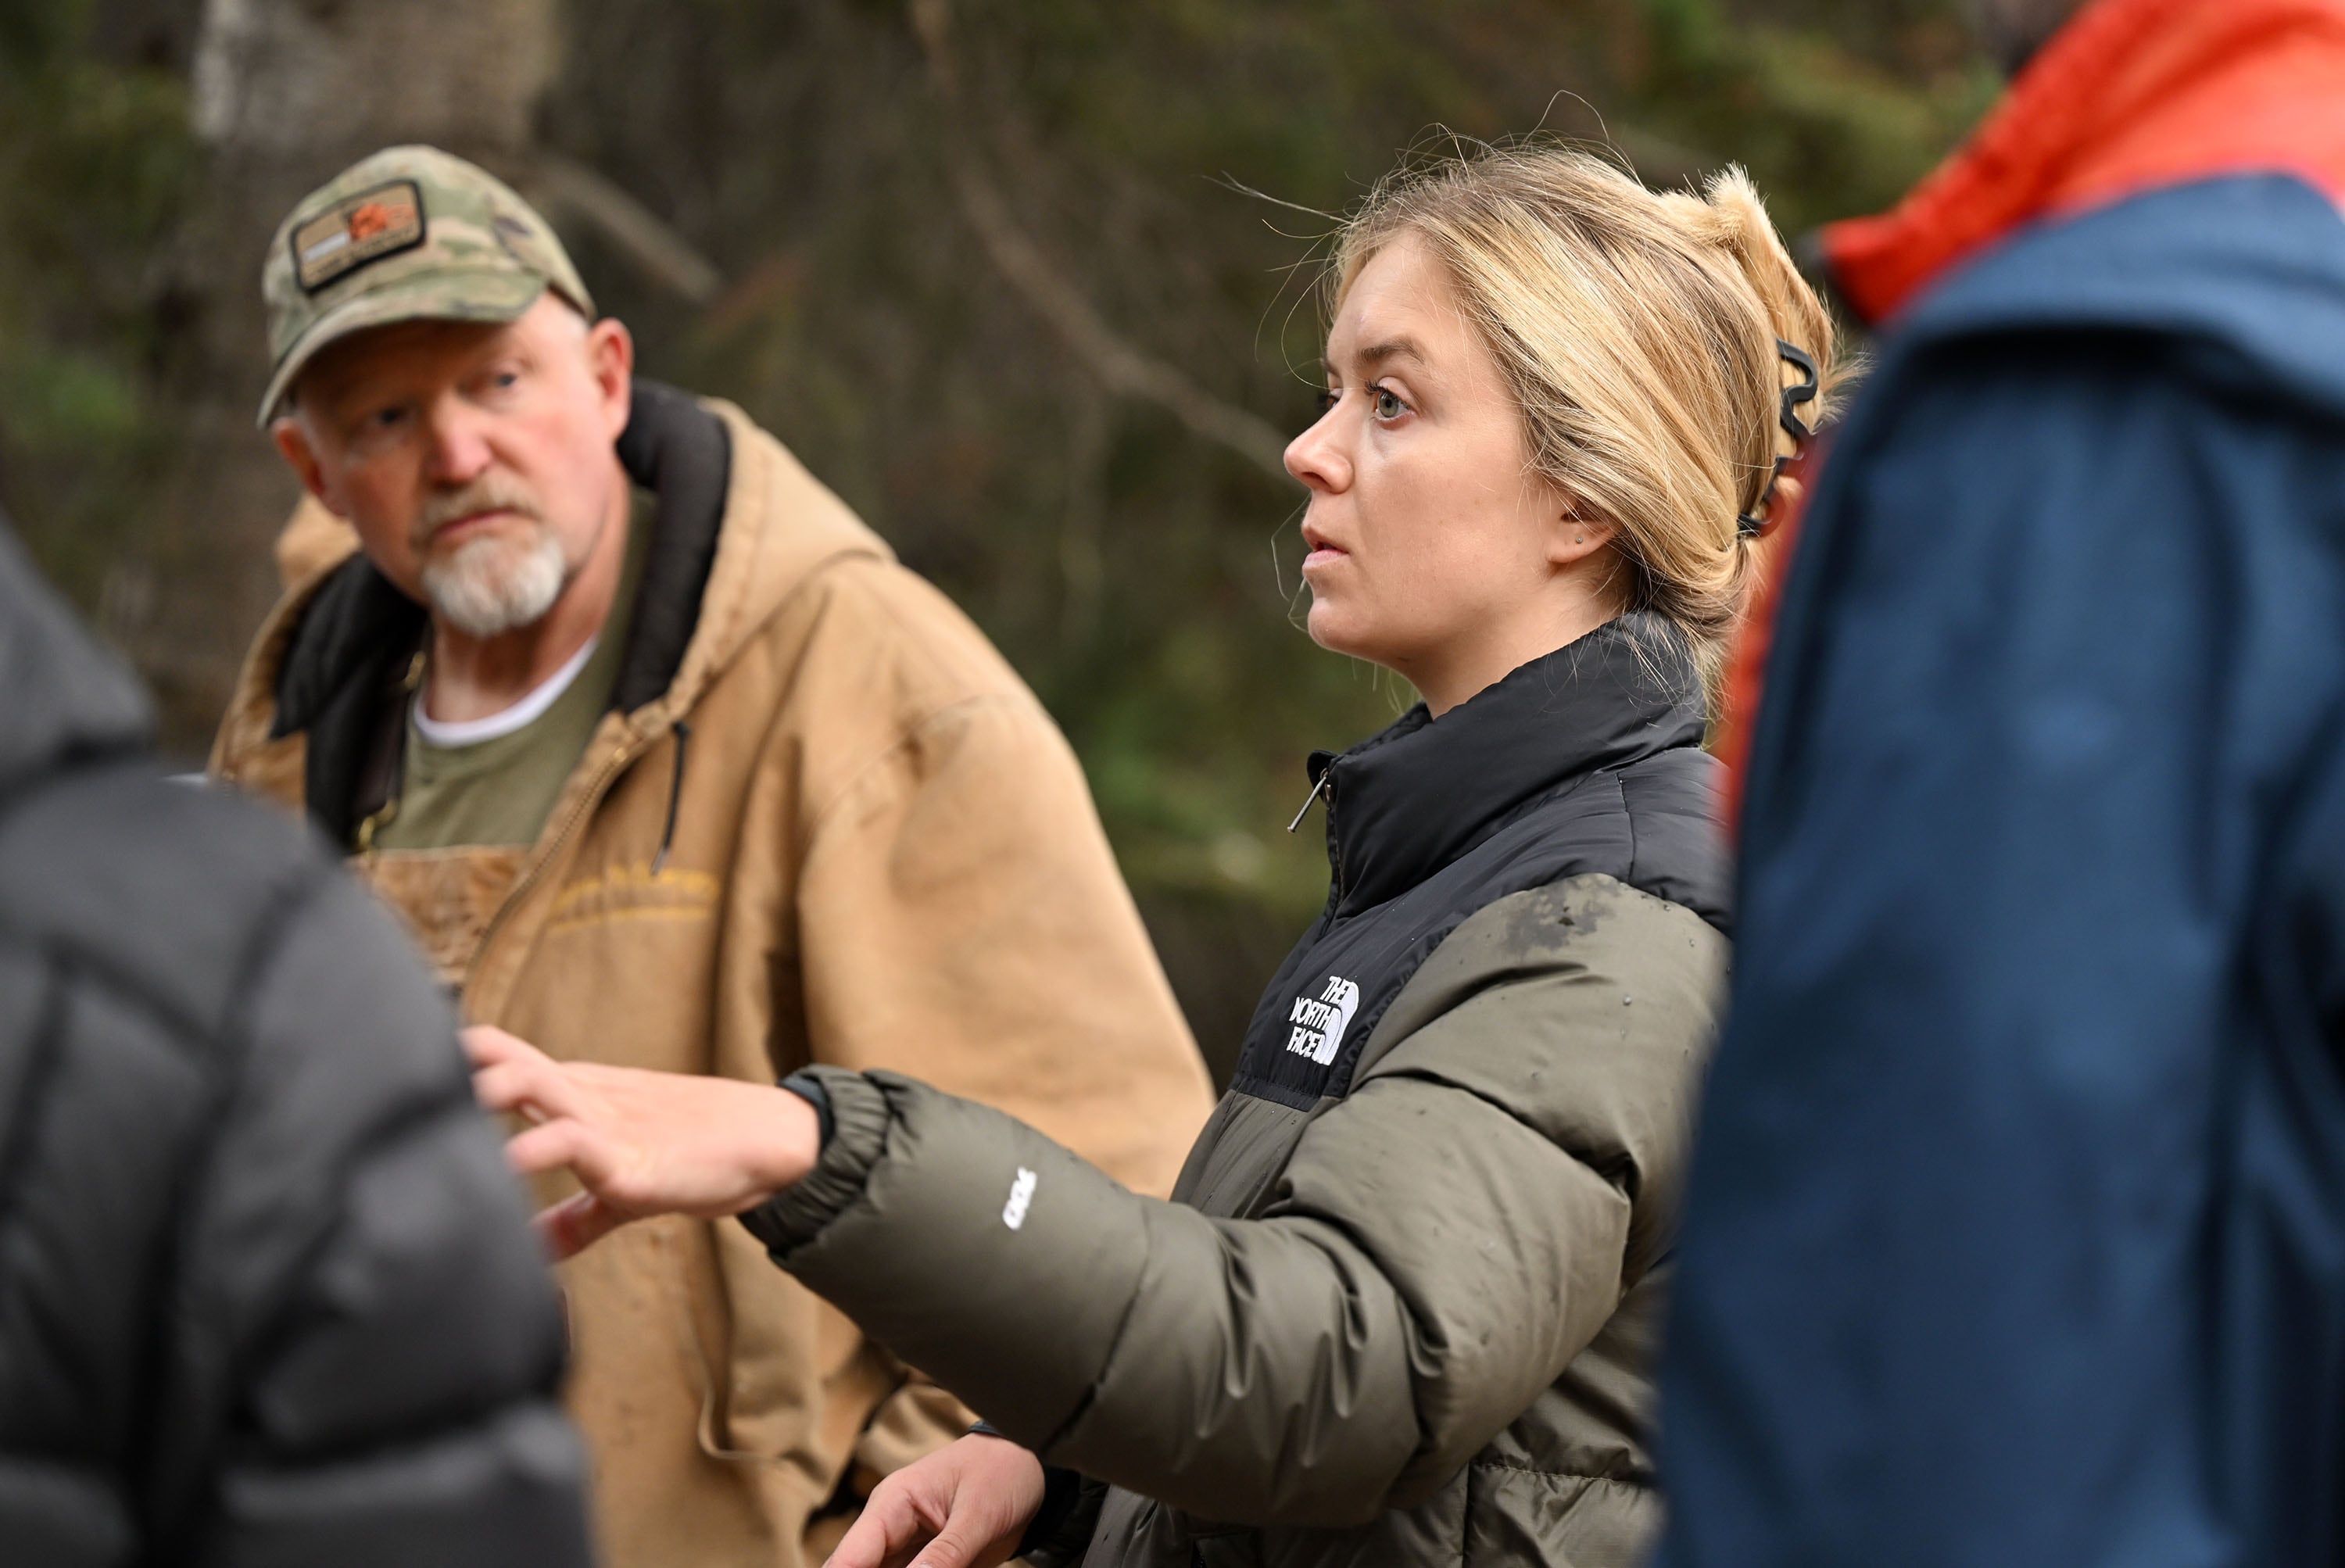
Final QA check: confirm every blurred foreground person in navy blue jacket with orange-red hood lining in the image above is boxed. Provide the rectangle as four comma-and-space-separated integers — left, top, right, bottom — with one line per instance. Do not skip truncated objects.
1663, 0, 2345, 1568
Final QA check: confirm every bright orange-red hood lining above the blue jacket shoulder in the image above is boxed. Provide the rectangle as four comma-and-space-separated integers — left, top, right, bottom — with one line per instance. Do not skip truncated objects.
1820, 0, 2345, 321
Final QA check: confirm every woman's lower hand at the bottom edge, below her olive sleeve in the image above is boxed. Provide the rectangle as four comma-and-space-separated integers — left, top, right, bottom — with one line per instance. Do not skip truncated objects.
823, 1434, 1044, 1568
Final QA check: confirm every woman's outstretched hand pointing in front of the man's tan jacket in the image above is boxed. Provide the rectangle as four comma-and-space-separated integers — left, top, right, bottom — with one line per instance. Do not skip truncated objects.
464, 1026, 823, 1258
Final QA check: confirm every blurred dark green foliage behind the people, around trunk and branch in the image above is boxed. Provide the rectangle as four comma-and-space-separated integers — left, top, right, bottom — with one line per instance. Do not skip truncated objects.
0, 0, 1993, 1064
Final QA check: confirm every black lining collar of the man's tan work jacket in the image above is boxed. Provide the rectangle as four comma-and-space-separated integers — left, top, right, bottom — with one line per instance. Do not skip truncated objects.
270, 380, 732, 843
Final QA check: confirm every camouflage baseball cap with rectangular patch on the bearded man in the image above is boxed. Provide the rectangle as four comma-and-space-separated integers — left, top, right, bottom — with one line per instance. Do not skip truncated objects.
260, 145, 593, 429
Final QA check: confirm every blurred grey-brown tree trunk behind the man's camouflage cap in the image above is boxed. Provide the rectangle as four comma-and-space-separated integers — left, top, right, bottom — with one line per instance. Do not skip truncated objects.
119, 0, 558, 755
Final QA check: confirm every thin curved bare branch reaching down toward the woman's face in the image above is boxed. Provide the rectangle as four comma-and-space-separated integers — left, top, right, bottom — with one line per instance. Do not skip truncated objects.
910, 0, 1287, 478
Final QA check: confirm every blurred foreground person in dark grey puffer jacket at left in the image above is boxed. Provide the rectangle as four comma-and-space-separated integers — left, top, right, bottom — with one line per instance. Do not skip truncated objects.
0, 510, 589, 1568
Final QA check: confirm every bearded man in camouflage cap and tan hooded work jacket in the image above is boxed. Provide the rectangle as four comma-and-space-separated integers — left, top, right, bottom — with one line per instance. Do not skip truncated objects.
213, 148, 1208, 1568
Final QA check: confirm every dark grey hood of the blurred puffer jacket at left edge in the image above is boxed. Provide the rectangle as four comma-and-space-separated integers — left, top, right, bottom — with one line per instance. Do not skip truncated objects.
0, 516, 152, 789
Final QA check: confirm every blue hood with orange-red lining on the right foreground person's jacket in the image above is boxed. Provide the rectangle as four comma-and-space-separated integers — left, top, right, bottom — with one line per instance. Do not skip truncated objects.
1717, 0, 2345, 825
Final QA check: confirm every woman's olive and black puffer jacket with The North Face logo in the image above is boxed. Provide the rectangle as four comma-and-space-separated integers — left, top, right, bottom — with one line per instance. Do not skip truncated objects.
746, 617, 1728, 1568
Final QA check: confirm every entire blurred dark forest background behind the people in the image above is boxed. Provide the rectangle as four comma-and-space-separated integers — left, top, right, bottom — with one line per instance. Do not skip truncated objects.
0, 0, 1993, 1059
